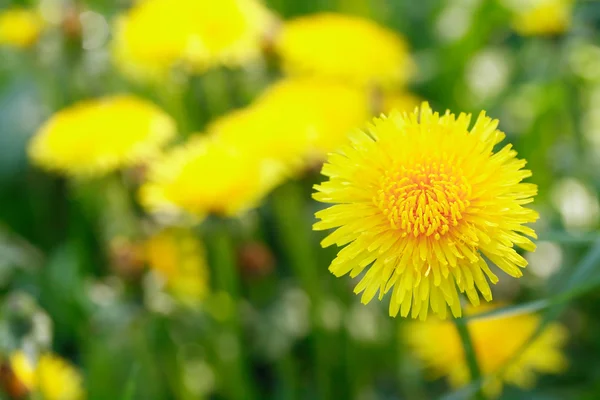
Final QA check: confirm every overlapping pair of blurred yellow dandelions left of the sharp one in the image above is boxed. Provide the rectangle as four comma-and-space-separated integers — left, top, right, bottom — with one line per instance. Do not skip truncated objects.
141, 78, 369, 217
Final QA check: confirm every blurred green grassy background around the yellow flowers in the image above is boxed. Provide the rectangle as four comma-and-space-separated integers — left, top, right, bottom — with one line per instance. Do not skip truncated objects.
0, 0, 600, 400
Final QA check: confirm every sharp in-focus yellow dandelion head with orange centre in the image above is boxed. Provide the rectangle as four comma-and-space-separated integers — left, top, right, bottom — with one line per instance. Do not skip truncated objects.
314, 103, 538, 319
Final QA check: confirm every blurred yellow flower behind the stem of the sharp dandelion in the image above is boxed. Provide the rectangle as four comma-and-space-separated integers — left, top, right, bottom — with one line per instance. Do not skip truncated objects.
403, 306, 567, 397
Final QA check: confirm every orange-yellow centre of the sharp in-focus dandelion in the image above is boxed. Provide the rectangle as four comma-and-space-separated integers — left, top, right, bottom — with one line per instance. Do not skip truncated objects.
373, 162, 471, 240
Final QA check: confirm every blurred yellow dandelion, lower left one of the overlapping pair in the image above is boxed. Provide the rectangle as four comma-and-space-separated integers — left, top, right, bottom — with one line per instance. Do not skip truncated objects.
140, 136, 281, 218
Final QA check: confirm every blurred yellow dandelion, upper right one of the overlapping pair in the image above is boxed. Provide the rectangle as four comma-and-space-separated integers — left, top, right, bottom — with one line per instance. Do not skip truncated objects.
207, 78, 369, 171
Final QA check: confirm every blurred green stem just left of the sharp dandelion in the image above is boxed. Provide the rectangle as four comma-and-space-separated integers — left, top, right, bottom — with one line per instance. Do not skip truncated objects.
272, 182, 332, 399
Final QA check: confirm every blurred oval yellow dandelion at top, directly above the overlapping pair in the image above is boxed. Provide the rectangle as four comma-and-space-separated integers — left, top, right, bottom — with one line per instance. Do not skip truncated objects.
275, 13, 412, 86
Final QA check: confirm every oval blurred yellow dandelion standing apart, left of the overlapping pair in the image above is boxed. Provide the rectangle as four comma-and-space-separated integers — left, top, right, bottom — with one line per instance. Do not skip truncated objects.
29, 95, 176, 177
